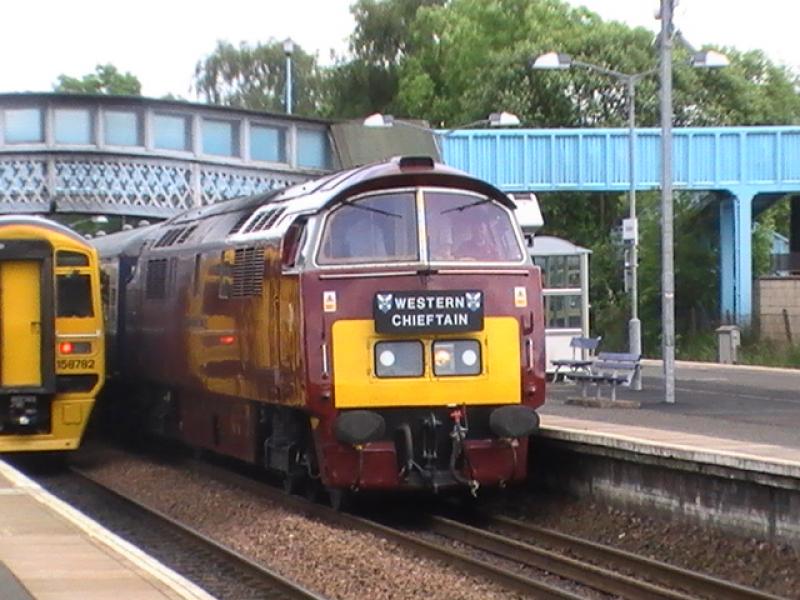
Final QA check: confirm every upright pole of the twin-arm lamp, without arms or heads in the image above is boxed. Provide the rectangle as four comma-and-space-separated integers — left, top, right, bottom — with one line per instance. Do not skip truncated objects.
626, 75, 642, 390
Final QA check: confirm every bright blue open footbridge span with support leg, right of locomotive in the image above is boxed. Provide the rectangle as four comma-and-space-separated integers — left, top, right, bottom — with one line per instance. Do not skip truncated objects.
442, 127, 800, 322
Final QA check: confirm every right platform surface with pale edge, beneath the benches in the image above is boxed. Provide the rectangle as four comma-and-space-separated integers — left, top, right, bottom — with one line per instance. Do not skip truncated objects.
540, 361, 800, 477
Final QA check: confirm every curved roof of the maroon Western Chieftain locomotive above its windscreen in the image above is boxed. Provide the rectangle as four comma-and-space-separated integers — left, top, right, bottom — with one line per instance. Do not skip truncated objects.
172, 156, 515, 225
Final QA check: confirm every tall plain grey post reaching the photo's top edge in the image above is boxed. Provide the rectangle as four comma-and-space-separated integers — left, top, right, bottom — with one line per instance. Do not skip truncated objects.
660, 0, 675, 404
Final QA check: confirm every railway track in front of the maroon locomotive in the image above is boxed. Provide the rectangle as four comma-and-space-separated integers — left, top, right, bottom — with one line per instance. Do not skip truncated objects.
184, 463, 780, 600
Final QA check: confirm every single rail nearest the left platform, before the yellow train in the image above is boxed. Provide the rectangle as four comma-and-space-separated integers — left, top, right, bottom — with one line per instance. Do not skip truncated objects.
70, 466, 326, 600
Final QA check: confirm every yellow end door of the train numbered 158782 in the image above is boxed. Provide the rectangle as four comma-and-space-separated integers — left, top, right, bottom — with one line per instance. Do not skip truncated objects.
0, 260, 42, 387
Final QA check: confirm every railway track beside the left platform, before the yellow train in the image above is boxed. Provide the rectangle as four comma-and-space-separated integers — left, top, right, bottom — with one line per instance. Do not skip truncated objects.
42, 467, 324, 600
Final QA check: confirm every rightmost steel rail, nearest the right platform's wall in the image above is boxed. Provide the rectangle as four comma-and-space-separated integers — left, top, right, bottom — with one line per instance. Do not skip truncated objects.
485, 516, 781, 600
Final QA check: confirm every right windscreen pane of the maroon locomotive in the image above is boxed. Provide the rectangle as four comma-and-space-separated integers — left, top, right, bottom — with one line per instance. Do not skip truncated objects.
425, 192, 523, 262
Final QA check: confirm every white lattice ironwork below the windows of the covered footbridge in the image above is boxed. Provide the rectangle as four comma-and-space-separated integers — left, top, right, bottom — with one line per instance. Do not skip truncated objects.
0, 153, 308, 217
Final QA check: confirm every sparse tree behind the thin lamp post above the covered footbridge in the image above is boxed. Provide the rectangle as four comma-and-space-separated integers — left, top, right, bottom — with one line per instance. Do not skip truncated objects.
194, 40, 323, 115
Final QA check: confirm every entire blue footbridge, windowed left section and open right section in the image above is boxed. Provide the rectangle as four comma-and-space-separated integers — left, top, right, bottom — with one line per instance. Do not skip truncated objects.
0, 94, 800, 321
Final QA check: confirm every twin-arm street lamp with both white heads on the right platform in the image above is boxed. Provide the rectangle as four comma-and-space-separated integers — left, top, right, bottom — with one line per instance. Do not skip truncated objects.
531, 41, 729, 402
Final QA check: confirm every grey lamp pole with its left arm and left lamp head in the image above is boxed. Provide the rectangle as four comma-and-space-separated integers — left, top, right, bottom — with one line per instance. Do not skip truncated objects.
531, 52, 656, 390
